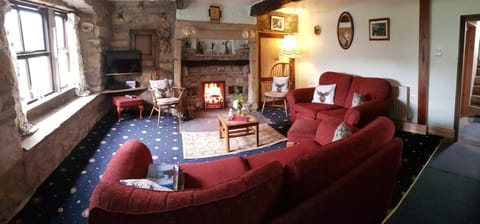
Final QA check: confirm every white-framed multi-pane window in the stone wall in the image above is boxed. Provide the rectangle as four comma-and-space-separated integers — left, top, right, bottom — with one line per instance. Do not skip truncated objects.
5, 1, 74, 104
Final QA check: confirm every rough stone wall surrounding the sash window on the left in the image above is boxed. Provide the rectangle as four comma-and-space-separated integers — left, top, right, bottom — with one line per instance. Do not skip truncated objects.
0, 0, 110, 223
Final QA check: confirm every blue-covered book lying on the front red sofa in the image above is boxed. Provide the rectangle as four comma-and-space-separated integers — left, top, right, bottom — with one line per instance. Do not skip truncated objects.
147, 163, 184, 191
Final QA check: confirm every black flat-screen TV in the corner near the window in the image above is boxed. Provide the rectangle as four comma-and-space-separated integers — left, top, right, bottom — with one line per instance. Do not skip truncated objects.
103, 50, 142, 75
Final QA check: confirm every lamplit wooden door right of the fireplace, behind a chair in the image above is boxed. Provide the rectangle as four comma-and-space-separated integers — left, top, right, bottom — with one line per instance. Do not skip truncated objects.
258, 33, 284, 105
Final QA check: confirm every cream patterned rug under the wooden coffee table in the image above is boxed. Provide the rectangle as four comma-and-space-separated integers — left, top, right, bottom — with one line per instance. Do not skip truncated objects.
182, 124, 287, 159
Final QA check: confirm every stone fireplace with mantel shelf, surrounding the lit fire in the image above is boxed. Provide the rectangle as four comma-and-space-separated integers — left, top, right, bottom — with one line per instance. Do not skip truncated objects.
174, 20, 258, 109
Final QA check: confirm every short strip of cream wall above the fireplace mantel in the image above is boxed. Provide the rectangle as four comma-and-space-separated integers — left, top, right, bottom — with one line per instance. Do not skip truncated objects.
177, 0, 257, 24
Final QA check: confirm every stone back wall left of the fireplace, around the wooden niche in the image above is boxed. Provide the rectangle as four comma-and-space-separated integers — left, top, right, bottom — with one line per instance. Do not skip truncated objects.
110, 1, 176, 99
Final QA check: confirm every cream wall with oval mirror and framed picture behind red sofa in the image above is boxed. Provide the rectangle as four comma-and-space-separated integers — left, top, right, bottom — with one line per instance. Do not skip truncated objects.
285, 0, 480, 129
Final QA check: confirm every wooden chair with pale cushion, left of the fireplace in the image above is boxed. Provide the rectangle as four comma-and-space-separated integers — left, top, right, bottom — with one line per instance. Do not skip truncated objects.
148, 79, 185, 127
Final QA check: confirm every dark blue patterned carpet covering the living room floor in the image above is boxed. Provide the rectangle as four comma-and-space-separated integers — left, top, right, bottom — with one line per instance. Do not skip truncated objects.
10, 108, 440, 224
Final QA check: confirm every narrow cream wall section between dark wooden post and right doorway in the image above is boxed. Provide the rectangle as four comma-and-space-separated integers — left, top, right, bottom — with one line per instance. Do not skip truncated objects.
428, 0, 480, 128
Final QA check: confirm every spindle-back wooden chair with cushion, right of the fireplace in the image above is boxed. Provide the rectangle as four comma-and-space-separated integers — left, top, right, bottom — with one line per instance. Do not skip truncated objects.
260, 62, 291, 117
